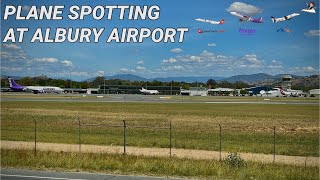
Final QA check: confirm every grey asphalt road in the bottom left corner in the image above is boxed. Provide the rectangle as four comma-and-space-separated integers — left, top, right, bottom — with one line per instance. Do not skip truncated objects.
1, 169, 180, 180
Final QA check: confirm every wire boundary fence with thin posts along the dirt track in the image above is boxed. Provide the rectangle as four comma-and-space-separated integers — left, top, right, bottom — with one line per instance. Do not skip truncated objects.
28, 116, 284, 163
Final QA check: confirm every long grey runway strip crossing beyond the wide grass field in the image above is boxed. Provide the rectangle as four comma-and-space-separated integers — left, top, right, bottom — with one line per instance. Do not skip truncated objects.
1, 93, 319, 104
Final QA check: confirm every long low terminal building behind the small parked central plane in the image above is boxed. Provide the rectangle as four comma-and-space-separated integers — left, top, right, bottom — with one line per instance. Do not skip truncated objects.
98, 85, 181, 95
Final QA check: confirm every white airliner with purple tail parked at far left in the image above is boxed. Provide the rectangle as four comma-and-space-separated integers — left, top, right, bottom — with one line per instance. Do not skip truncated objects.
8, 77, 63, 94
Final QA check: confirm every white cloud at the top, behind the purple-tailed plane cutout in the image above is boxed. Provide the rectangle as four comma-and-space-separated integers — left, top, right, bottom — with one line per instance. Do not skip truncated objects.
226, 2, 262, 16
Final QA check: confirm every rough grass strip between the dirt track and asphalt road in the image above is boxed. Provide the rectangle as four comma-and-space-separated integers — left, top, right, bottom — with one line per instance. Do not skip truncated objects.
1, 149, 319, 180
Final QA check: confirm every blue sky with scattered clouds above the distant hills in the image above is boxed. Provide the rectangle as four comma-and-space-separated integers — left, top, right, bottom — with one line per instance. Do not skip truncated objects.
1, 0, 320, 80
